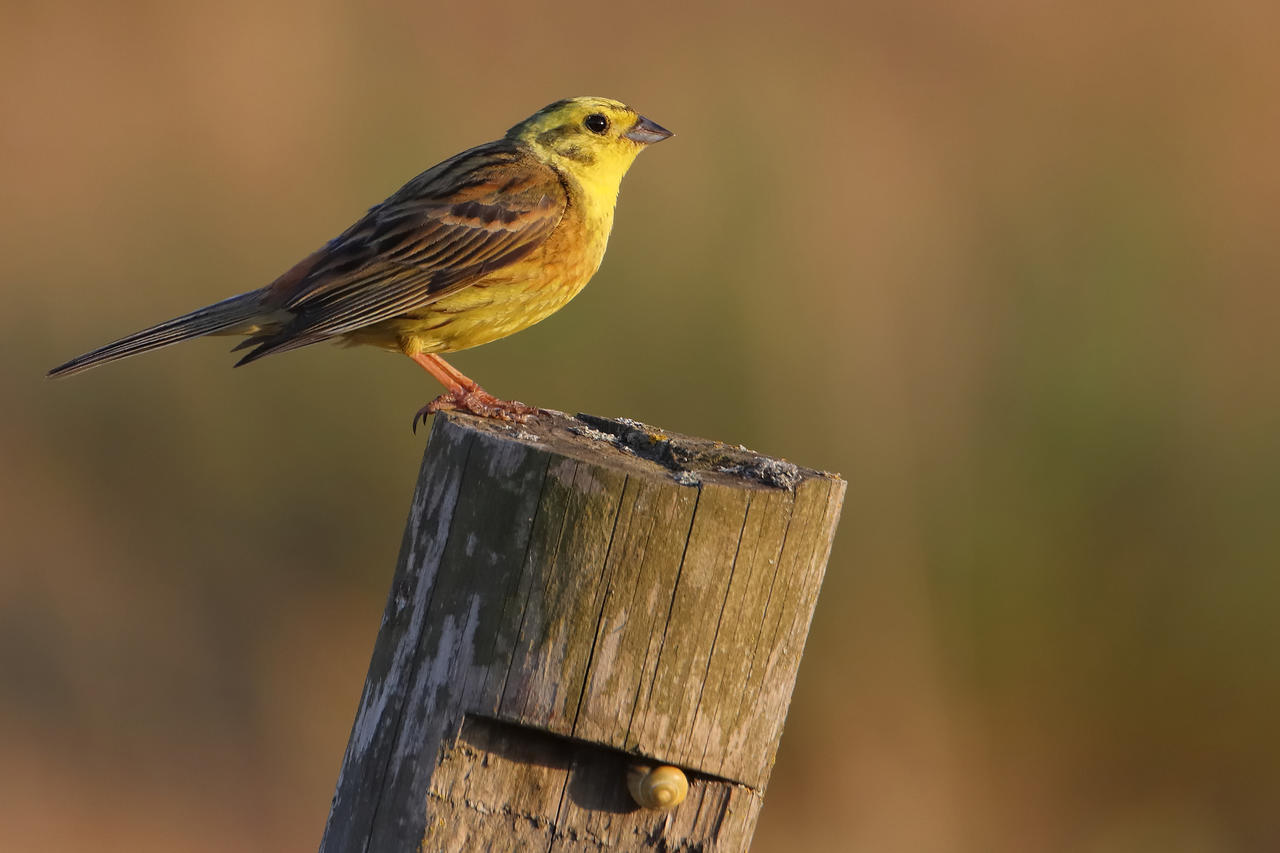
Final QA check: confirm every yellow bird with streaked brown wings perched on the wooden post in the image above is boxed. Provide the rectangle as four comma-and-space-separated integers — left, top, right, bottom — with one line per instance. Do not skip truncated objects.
49, 97, 672, 432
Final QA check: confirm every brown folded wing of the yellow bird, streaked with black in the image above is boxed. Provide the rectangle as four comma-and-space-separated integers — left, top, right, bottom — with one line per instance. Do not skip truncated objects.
241, 140, 567, 364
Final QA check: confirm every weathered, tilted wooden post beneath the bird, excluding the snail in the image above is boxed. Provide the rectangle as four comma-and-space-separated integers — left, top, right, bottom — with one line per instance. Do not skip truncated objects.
320, 414, 845, 853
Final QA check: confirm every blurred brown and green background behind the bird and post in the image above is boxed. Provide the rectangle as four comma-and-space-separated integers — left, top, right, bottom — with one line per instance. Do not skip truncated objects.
0, 0, 1280, 853
